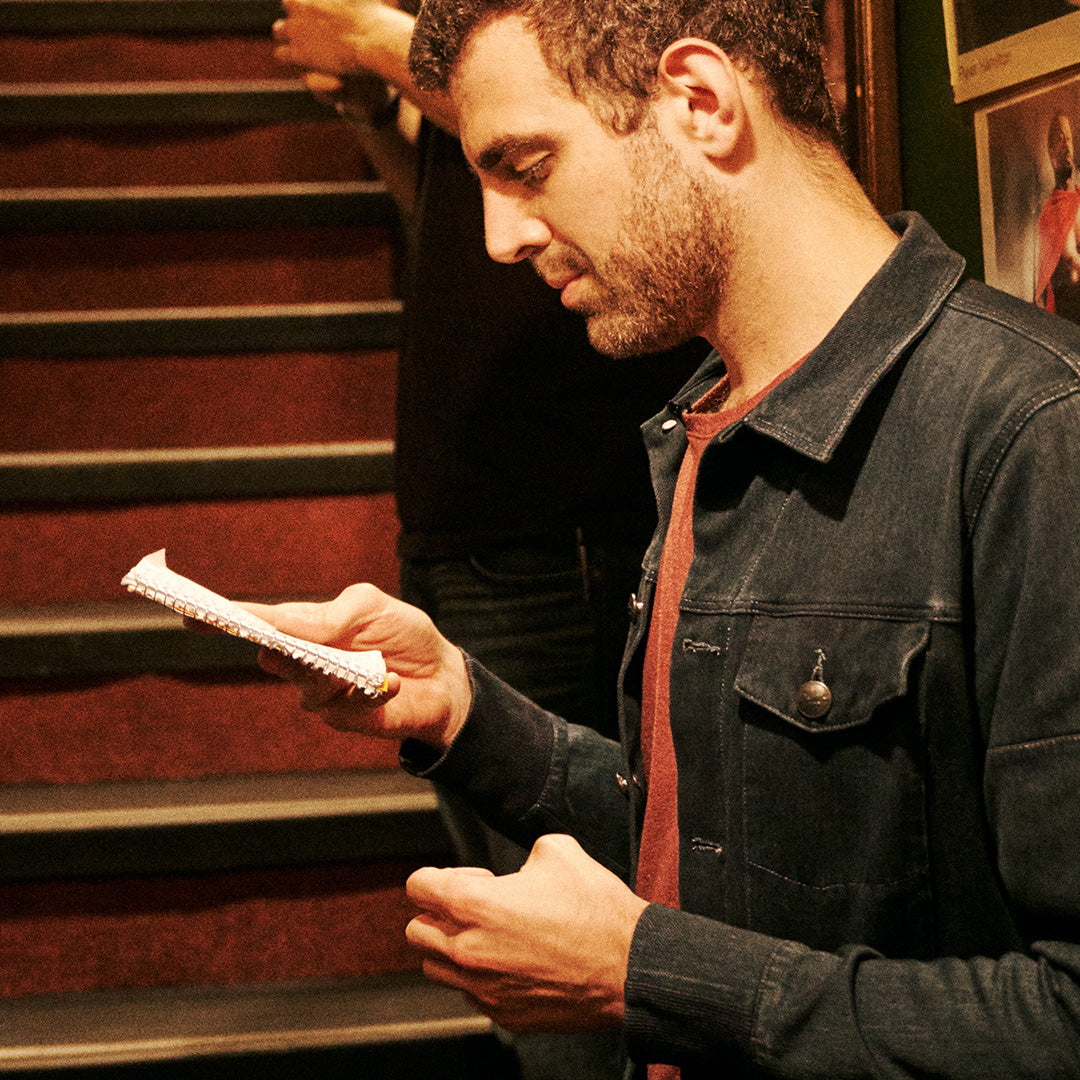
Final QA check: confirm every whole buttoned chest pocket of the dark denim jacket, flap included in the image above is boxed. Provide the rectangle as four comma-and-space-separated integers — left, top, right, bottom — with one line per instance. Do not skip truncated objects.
734, 616, 929, 948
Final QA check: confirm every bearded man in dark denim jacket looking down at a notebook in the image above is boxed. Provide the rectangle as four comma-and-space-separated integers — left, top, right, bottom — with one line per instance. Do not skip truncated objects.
247, 0, 1080, 1080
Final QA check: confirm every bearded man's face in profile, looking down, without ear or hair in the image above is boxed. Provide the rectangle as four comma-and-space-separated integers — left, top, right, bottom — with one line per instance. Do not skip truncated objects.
450, 16, 731, 356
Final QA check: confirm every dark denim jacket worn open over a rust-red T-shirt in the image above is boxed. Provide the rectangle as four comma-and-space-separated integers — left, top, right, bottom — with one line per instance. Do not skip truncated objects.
404, 215, 1080, 1080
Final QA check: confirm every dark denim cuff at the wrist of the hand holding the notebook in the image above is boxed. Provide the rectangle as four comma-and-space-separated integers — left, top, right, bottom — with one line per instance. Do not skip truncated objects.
399, 656, 555, 820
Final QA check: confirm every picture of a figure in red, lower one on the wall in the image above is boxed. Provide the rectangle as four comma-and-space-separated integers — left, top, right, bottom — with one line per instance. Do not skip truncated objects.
975, 66, 1080, 322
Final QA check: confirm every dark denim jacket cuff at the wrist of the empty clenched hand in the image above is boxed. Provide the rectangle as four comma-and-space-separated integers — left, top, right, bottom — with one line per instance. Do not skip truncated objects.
625, 904, 778, 1065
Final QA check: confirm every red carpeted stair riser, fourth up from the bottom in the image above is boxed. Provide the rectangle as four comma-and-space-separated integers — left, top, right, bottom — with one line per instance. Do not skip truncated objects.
0, 351, 395, 453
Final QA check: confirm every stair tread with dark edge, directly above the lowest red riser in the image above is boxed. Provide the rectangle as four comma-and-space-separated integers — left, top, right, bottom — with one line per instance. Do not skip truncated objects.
0, 761, 451, 881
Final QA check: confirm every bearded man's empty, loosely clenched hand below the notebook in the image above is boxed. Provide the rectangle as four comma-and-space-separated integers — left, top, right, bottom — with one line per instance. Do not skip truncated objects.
406, 836, 647, 1031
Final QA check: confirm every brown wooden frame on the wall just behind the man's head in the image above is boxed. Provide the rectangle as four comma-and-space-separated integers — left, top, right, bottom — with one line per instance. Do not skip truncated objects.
816, 0, 902, 214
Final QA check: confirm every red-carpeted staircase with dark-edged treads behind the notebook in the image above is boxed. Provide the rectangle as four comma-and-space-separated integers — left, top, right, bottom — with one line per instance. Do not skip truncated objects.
0, 0, 513, 1080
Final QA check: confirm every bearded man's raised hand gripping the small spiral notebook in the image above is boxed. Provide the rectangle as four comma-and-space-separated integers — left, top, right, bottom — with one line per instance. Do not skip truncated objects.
243, 585, 472, 748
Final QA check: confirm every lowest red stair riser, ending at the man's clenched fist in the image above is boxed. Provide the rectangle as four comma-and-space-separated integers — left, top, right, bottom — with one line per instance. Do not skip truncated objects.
0, 862, 418, 998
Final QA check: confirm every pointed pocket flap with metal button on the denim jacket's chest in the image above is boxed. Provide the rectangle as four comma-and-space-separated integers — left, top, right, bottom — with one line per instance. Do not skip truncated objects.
735, 616, 930, 732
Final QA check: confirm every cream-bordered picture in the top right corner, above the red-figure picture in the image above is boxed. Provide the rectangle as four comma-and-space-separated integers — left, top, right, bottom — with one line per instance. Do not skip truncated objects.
942, 0, 1080, 102
